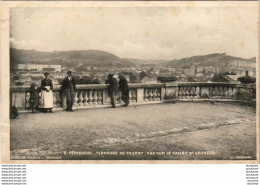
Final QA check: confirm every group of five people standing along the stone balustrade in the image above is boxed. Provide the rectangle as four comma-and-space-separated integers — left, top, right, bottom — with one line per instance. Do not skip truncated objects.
30, 71, 129, 113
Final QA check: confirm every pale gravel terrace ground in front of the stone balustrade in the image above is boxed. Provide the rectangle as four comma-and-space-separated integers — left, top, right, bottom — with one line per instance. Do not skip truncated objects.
10, 102, 256, 160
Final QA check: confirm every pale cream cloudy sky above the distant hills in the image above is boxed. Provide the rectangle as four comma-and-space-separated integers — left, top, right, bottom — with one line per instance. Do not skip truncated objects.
10, 7, 258, 60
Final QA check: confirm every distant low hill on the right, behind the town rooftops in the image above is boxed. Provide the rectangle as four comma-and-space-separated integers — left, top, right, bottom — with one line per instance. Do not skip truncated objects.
163, 53, 256, 67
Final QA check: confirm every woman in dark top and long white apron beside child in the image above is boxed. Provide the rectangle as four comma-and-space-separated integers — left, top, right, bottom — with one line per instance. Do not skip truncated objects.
41, 73, 53, 113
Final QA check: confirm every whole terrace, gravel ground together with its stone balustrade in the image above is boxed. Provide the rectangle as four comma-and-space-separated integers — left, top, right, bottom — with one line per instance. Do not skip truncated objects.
10, 83, 256, 160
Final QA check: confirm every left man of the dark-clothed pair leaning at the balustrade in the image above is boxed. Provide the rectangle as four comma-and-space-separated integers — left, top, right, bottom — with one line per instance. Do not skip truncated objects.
105, 74, 118, 108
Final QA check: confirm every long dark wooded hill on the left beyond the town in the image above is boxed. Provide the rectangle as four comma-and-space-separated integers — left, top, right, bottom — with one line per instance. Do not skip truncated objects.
10, 48, 135, 67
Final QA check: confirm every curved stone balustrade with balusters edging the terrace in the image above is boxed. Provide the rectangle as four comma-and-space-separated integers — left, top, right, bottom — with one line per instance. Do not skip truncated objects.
10, 82, 256, 109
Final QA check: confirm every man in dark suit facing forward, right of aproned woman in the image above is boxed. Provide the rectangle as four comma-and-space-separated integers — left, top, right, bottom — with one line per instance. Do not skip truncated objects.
61, 71, 76, 112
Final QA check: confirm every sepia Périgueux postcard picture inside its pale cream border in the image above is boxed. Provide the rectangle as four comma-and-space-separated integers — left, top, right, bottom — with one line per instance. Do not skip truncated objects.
5, 2, 259, 163
